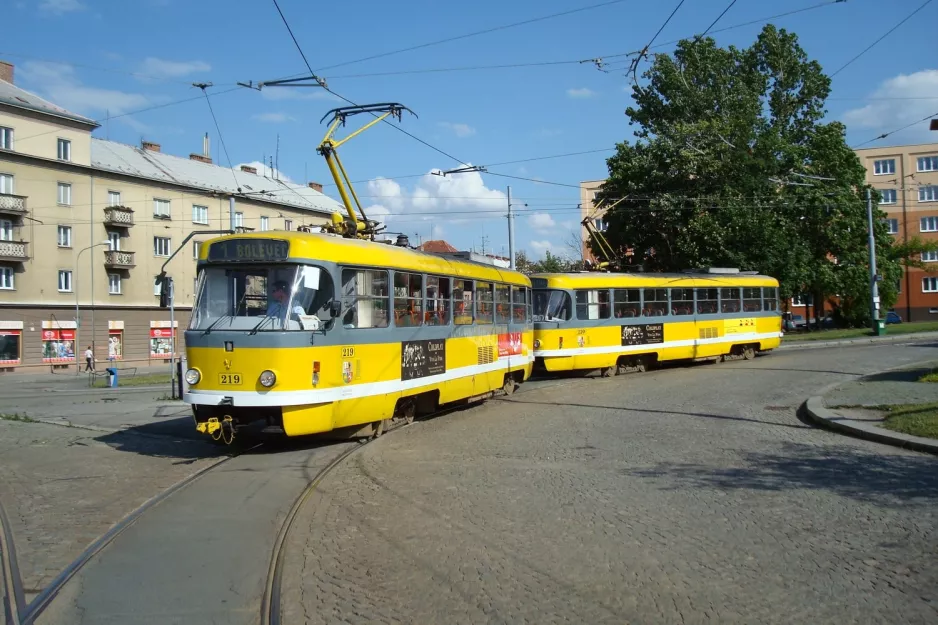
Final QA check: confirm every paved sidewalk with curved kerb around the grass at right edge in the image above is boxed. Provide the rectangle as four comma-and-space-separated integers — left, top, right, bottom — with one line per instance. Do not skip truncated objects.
804, 361, 938, 454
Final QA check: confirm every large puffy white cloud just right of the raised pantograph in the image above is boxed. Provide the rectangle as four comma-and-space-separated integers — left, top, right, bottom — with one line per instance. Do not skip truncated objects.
361, 170, 508, 229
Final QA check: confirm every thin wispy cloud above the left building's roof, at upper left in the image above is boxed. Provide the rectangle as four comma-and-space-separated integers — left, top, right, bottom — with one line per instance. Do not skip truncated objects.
17, 61, 151, 119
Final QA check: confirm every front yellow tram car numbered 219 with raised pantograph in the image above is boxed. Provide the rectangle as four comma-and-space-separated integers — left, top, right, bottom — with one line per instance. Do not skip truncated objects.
183, 232, 534, 441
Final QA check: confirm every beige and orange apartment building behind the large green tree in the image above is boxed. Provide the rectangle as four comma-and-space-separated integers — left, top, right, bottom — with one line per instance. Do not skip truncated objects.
580, 143, 938, 321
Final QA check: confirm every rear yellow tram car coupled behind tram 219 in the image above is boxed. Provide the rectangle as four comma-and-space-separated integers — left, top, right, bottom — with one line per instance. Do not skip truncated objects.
531, 269, 782, 375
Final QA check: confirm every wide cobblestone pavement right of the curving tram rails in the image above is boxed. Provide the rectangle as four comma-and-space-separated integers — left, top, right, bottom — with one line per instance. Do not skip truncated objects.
283, 346, 938, 624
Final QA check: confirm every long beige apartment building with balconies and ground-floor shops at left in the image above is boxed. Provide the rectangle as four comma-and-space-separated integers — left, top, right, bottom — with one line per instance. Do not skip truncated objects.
0, 62, 343, 371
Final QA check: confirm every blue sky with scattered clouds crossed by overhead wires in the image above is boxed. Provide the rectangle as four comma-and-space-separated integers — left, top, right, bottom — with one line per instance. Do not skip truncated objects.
0, 0, 938, 257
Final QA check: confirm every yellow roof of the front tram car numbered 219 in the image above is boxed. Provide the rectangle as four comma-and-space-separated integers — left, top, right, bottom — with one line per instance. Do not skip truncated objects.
199, 231, 530, 286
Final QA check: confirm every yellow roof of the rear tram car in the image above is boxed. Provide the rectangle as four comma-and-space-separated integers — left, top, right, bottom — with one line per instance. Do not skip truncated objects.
531, 272, 778, 289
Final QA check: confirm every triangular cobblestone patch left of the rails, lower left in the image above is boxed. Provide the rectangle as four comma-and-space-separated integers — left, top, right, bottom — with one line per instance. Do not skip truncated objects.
0, 420, 219, 599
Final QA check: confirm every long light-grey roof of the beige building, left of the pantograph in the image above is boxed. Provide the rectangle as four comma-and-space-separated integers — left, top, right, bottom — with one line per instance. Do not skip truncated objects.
91, 138, 343, 214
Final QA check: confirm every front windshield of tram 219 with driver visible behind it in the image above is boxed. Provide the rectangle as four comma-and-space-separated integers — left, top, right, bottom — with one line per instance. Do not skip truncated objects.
189, 265, 333, 332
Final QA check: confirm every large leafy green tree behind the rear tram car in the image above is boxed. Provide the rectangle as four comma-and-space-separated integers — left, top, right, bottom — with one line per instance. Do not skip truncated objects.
598, 25, 901, 323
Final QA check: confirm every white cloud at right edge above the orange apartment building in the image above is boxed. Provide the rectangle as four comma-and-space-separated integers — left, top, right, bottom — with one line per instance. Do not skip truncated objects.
841, 69, 938, 142
